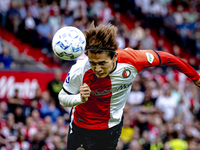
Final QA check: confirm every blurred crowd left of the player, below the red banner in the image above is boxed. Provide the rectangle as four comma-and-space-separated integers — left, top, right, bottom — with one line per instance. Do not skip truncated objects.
0, 68, 70, 150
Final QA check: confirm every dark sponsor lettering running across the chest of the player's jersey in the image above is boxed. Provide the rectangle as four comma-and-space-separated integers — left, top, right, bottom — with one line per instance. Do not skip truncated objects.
91, 83, 132, 95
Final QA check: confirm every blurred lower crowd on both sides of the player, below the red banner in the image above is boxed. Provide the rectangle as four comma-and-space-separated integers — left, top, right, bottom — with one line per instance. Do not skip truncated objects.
0, 68, 200, 150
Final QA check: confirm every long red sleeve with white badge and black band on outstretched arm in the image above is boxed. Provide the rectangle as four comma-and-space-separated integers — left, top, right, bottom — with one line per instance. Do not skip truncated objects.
118, 48, 200, 82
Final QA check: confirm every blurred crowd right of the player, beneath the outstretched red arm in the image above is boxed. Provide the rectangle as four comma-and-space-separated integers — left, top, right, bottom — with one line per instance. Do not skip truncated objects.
117, 68, 200, 150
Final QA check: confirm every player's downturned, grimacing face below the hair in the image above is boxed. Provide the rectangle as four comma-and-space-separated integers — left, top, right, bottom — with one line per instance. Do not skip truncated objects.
88, 51, 117, 78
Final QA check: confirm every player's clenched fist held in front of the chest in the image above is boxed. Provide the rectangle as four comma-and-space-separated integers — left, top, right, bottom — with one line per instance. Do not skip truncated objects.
79, 83, 91, 102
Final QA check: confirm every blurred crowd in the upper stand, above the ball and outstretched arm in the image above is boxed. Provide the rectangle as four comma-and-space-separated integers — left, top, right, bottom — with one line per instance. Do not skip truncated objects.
0, 0, 200, 69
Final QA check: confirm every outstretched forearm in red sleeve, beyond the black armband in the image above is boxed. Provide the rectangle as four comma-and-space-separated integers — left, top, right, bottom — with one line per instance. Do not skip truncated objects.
154, 51, 200, 87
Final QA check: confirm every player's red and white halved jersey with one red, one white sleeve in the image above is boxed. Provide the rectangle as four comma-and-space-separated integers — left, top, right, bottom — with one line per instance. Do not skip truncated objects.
63, 48, 199, 129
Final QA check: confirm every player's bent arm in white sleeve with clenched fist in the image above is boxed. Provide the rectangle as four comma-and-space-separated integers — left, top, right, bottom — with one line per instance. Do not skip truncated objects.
58, 60, 91, 107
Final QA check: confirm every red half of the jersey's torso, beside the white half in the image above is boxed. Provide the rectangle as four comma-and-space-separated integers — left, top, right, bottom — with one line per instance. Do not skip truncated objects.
73, 69, 112, 129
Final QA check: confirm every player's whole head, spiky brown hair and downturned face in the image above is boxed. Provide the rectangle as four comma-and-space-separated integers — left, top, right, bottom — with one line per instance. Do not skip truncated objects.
84, 23, 118, 78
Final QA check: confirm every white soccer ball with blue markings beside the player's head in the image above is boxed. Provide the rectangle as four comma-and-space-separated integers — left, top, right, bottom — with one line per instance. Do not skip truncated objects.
52, 26, 86, 60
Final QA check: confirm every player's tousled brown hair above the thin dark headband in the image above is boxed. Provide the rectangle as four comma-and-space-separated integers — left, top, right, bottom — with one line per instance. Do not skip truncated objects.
83, 22, 118, 58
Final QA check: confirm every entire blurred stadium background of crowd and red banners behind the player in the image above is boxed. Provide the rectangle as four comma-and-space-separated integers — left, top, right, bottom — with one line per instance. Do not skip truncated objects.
0, 0, 200, 150
